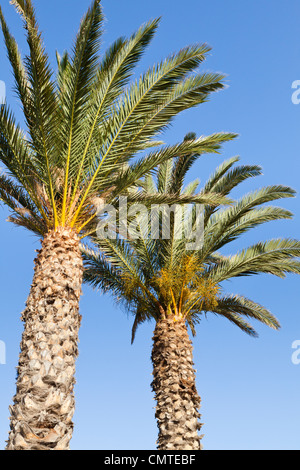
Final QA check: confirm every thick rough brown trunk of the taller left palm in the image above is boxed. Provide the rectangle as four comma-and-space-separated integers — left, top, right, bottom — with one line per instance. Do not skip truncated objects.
6, 227, 83, 450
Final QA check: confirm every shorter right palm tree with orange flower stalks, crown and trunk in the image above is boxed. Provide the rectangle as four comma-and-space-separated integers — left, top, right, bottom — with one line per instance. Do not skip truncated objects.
83, 145, 300, 450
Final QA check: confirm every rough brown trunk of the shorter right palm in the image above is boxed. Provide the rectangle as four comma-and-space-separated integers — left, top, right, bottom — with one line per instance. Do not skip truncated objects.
152, 318, 202, 450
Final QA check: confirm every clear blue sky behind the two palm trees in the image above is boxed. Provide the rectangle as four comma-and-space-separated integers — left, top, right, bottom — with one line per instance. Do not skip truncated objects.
0, 0, 300, 450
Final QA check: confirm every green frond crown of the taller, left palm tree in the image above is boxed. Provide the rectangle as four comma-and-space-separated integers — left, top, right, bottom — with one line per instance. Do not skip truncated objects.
0, 0, 234, 237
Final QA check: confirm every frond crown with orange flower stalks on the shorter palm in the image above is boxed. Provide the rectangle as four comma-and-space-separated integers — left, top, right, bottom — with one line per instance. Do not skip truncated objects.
84, 138, 300, 338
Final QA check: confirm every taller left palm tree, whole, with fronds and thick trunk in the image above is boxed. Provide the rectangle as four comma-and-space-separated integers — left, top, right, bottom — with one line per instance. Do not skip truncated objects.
0, 0, 234, 450
